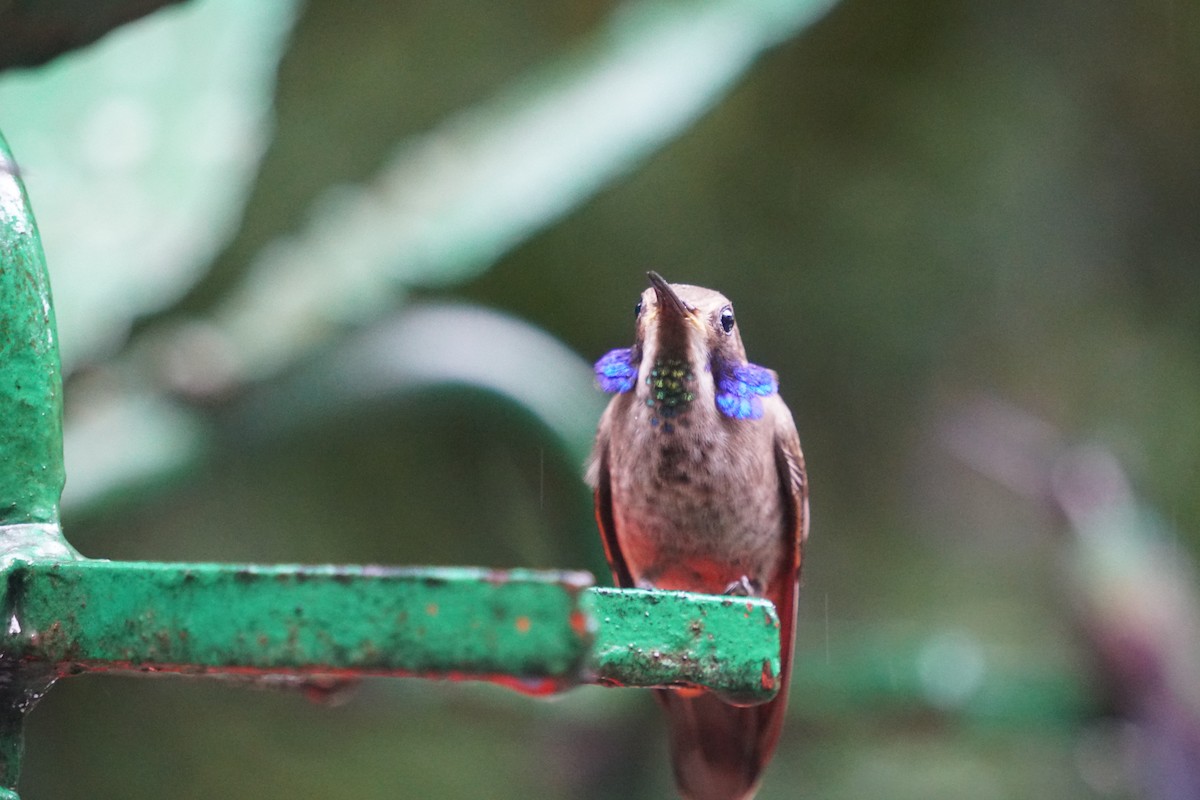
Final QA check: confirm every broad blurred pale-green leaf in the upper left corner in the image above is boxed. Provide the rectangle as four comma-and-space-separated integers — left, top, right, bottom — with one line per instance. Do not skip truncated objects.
0, 0, 296, 372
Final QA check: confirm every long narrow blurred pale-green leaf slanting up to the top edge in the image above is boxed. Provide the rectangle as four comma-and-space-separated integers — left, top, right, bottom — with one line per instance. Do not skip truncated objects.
194, 0, 829, 377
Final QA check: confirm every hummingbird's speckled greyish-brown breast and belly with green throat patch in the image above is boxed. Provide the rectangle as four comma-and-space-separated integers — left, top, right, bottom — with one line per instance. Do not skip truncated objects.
600, 388, 785, 593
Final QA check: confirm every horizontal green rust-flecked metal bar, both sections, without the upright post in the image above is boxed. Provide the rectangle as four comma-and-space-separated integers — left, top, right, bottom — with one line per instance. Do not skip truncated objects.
5, 560, 779, 702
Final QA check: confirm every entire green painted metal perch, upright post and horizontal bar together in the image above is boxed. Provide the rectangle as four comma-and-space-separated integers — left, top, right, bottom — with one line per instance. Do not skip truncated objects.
0, 131, 780, 800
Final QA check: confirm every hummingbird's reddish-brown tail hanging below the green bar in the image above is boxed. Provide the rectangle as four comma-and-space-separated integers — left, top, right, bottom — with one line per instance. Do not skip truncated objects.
658, 688, 787, 800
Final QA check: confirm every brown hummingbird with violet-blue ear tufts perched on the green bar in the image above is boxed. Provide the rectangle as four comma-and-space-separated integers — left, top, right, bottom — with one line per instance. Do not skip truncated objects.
587, 272, 809, 800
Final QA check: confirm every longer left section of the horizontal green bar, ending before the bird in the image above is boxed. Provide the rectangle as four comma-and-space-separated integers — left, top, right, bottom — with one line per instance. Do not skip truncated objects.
8, 561, 592, 691
